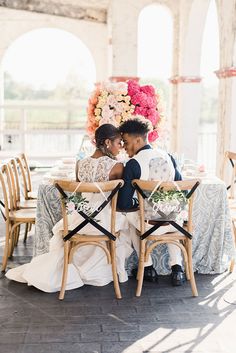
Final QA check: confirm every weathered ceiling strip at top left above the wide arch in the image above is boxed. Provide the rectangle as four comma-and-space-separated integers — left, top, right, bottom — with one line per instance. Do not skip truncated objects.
0, 0, 110, 23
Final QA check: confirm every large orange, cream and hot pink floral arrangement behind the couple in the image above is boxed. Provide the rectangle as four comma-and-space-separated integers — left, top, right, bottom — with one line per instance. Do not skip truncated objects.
87, 80, 163, 142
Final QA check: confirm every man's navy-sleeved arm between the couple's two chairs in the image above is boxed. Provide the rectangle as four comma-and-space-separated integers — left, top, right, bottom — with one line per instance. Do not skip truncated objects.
117, 159, 141, 210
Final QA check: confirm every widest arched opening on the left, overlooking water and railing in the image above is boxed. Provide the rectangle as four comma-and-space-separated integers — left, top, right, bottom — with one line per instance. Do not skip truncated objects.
2, 28, 96, 155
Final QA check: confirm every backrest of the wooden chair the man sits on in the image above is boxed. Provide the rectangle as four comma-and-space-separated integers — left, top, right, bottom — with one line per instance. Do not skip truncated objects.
132, 179, 200, 233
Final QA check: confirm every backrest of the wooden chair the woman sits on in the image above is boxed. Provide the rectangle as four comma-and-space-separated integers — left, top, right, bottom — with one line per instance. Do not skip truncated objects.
54, 179, 124, 239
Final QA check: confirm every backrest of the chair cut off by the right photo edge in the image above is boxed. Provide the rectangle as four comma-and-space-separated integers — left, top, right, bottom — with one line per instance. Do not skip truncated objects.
223, 151, 236, 198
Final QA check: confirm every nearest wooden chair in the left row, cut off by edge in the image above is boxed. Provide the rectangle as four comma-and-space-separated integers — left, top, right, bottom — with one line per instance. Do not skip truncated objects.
0, 164, 36, 271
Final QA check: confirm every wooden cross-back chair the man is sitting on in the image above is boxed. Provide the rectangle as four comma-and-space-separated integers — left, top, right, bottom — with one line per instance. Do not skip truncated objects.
132, 179, 200, 297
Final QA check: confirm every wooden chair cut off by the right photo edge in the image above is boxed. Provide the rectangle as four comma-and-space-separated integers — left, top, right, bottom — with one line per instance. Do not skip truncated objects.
223, 151, 236, 272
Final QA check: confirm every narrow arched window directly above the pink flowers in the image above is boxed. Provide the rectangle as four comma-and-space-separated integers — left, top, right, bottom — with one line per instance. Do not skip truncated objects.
138, 4, 173, 113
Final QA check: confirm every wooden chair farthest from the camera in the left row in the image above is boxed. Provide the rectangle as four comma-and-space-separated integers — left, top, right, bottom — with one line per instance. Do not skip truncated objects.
16, 153, 37, 200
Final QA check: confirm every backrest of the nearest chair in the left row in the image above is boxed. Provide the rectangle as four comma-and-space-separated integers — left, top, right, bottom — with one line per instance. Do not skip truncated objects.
0, 164, 15, 219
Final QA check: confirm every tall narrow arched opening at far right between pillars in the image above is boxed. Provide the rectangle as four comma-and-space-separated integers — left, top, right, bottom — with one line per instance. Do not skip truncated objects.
198, 0, 219, 171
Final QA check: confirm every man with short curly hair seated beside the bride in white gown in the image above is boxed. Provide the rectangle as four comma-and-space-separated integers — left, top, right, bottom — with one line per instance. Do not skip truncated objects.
118, 118, 185, 286
